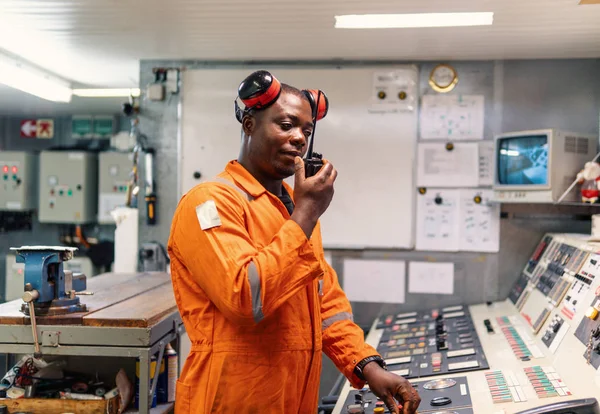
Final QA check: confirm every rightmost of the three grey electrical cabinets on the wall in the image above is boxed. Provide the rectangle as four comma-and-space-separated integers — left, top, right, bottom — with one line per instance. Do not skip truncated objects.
98, 151, 133, 224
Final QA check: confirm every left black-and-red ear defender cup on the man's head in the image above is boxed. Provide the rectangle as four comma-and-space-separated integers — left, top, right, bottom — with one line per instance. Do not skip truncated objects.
234, 70, 281, 123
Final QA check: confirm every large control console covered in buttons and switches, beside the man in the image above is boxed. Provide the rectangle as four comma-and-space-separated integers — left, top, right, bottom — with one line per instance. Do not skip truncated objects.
332, 234, 600, 414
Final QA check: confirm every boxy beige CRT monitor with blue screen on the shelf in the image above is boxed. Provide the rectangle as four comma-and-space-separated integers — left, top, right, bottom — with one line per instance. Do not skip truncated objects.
493, 129, 597, 203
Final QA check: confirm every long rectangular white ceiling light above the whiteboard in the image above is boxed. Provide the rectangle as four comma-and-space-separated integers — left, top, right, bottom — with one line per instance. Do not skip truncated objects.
335, 12, 494, 29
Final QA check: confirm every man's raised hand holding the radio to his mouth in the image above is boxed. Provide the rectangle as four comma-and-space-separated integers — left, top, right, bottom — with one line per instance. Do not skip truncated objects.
291, 157, 337, 238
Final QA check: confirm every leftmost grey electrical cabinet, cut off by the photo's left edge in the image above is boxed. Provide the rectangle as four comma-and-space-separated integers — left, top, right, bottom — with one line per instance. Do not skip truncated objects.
0, 151, 37, 211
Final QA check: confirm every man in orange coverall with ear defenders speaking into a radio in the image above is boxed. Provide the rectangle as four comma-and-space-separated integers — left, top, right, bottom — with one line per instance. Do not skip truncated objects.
168, 71, 420, 414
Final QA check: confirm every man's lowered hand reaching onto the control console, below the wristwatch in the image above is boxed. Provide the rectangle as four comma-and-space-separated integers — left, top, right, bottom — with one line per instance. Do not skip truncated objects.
363, 362, 421, 414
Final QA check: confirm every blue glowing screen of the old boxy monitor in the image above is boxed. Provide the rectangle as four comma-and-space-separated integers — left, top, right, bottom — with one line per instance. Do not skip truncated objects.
497, 135, 548, 185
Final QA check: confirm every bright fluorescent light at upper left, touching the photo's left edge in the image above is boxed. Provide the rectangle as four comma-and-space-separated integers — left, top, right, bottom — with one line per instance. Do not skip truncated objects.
0, 53, 71, 102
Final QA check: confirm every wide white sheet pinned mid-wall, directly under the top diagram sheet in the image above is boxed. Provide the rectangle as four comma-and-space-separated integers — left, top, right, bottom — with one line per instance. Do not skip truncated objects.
417, 142, 479, 187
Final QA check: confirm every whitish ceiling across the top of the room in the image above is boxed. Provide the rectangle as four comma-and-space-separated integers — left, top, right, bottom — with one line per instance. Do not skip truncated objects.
0, 0, 600, 87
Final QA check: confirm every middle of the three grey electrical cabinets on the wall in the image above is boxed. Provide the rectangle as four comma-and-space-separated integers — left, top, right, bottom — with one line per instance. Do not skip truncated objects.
39, 151, 98, 224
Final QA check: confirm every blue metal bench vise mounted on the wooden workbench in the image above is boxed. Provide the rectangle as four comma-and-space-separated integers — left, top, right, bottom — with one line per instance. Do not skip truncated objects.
11, 246, 87, 316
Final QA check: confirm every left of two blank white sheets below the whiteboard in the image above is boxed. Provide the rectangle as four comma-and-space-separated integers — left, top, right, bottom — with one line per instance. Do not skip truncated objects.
343, 259, 406, 303
